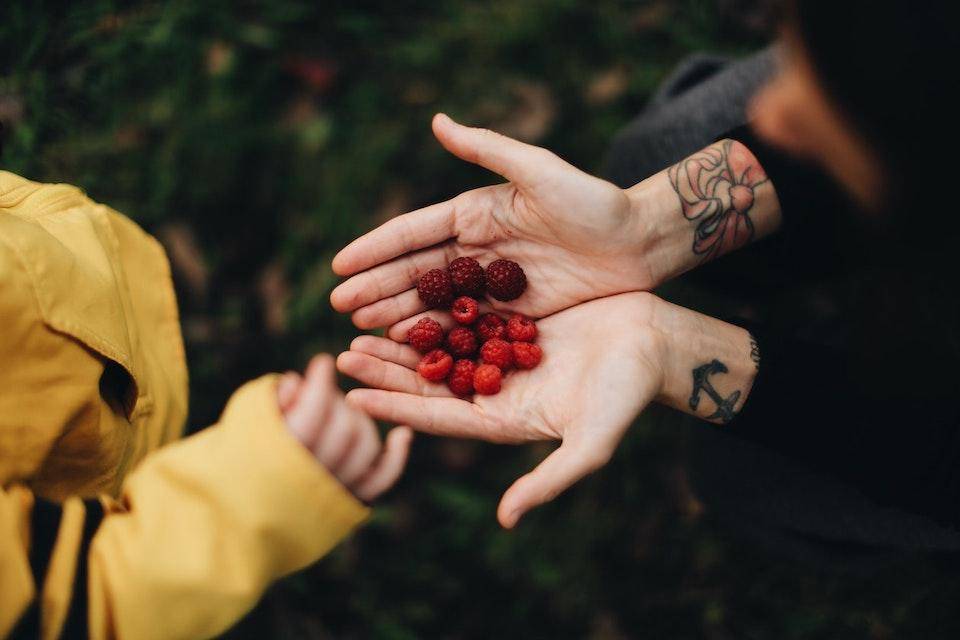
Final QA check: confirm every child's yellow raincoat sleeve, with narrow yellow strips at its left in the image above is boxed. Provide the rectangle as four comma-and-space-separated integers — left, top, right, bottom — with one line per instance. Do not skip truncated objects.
0, 376, 367, 638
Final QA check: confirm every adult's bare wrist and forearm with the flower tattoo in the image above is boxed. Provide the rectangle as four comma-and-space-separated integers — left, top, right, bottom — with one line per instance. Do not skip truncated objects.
626, 139, 781, 288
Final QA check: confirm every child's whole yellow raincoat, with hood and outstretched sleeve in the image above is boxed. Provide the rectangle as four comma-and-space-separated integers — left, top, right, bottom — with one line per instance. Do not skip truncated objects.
0, 171, 367, 638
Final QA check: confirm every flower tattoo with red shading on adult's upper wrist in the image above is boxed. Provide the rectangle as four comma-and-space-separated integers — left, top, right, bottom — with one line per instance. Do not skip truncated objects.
667, 140, 767, 262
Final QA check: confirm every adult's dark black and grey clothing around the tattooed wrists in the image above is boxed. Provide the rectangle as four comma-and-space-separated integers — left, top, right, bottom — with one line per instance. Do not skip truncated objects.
608, 50, 960, 560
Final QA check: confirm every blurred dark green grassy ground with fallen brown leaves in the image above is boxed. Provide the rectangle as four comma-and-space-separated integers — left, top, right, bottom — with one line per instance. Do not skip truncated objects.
0, 0, 960, 639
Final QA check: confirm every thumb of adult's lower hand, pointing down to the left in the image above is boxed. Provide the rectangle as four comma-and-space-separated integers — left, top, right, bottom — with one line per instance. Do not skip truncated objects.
497, 441, 610, 529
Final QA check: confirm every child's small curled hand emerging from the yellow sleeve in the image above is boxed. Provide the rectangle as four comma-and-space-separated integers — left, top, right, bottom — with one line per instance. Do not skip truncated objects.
277, 354, 413, 502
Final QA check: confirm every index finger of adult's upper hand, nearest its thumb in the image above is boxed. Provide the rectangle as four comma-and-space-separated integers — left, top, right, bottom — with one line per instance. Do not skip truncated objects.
333, 200, 456, 276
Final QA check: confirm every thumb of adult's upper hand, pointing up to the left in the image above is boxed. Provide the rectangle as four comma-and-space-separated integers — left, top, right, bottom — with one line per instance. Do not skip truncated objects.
433, 113, 563, 186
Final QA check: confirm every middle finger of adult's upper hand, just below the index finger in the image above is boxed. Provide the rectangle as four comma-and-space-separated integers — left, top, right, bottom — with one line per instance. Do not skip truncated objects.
330, 243, 455, 313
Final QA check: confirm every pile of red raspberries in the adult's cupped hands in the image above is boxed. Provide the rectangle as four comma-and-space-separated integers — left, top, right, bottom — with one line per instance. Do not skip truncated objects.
407, 258, 543, 397
